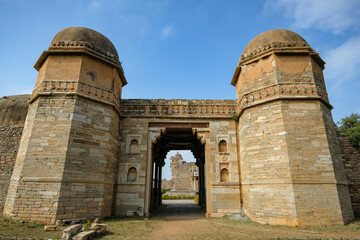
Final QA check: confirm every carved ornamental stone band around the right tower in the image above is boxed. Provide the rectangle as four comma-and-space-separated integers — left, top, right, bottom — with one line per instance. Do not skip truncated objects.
237, 82, 332, 115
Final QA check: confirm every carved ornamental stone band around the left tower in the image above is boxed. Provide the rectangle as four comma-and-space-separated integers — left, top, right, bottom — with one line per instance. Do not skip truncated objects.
30, 80, 120, 111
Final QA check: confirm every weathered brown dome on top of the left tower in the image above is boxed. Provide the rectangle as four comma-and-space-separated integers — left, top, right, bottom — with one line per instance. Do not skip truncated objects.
50, 27, 119, 59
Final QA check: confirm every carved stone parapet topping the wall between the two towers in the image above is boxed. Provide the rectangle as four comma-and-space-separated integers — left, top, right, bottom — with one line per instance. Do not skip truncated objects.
120, 99, 236, 118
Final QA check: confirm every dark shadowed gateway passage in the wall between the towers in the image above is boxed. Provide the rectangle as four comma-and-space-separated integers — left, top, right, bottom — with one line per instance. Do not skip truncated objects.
150, 126, 206, 217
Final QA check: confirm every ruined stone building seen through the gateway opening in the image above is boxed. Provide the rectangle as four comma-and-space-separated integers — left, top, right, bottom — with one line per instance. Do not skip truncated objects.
161, 153, 199, 196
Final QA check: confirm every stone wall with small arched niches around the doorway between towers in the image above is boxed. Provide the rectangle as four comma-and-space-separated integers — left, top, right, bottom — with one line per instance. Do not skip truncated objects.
116, 99, 241, 217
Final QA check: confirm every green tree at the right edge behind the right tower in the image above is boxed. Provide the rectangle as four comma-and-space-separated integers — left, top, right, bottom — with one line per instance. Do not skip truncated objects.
338, 113, 360, 151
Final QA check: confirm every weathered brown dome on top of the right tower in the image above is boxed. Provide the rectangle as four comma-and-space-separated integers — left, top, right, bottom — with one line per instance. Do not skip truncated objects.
242, 29, 309, 58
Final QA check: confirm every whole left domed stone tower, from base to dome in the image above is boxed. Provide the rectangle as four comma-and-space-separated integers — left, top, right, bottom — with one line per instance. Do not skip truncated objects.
4, 27, 127, 223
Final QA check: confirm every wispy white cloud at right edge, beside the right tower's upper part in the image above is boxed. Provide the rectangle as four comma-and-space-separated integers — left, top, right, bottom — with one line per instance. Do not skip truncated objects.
324, 35, 360, 94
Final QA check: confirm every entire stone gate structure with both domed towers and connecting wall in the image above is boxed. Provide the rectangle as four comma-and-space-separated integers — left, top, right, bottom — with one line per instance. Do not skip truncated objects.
0, 27, 360, 226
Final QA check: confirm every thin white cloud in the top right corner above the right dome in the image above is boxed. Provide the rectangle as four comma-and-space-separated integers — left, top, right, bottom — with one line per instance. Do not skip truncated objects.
274, 0, 360, 34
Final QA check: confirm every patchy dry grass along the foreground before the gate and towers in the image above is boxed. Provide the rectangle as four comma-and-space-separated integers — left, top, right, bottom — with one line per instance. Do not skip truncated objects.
0, 217, 360, 240
